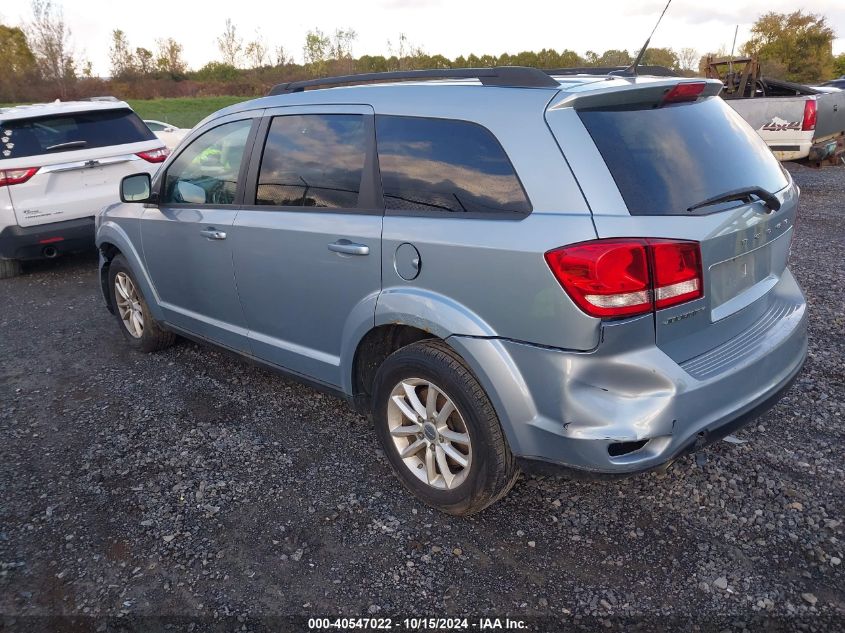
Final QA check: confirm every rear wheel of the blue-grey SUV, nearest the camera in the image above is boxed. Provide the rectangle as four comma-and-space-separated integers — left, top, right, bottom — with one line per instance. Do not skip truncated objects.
373, 339, 519, 516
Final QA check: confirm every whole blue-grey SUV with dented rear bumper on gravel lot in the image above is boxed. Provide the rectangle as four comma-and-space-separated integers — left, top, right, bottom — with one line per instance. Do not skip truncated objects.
97, 68, 807, 514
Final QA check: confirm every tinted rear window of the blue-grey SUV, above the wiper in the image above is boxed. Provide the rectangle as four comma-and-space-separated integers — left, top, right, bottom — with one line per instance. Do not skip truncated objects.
579, 97, 787, 215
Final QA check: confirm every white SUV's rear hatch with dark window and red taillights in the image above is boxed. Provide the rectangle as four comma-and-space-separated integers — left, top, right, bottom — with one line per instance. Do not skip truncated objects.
0, 108, 165, 227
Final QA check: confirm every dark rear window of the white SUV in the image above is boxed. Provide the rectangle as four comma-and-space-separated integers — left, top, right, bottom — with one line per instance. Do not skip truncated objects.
0, 109, 156, 158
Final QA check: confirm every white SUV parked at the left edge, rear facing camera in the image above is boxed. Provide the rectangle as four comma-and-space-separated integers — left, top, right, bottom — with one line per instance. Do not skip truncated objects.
0, 98, 170, 279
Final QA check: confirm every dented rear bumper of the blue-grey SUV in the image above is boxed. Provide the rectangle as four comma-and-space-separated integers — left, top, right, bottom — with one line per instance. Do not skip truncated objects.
450, 271, 807, 476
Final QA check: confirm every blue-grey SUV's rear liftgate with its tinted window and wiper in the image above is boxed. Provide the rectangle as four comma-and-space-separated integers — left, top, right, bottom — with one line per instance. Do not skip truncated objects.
547, 80, 798, 363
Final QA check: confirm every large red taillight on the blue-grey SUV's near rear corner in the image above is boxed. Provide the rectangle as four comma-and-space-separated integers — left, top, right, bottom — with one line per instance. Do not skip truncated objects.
545, 239, 703, 318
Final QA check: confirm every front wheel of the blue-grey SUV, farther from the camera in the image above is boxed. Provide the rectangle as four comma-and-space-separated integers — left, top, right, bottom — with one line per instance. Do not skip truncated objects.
109, 255, 176, 352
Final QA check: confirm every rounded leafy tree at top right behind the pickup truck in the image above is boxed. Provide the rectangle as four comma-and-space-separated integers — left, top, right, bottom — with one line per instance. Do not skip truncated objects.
743, 9, 836, 83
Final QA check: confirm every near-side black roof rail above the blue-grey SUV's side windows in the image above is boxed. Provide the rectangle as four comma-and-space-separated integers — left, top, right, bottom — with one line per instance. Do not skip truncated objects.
267, 66, 560, 96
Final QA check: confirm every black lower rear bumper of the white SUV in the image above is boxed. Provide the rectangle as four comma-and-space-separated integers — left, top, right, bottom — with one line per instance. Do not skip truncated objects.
0, 216, 94, 259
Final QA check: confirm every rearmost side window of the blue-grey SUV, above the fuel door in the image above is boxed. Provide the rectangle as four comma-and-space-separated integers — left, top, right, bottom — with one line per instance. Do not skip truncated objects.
376, 115, 531, 214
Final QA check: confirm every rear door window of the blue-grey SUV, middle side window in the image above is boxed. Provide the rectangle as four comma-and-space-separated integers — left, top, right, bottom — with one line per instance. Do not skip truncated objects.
255, 114, 367, 209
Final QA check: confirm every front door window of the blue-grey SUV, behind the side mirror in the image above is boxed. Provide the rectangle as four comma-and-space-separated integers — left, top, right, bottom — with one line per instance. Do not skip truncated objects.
162, 119, 252, 204
